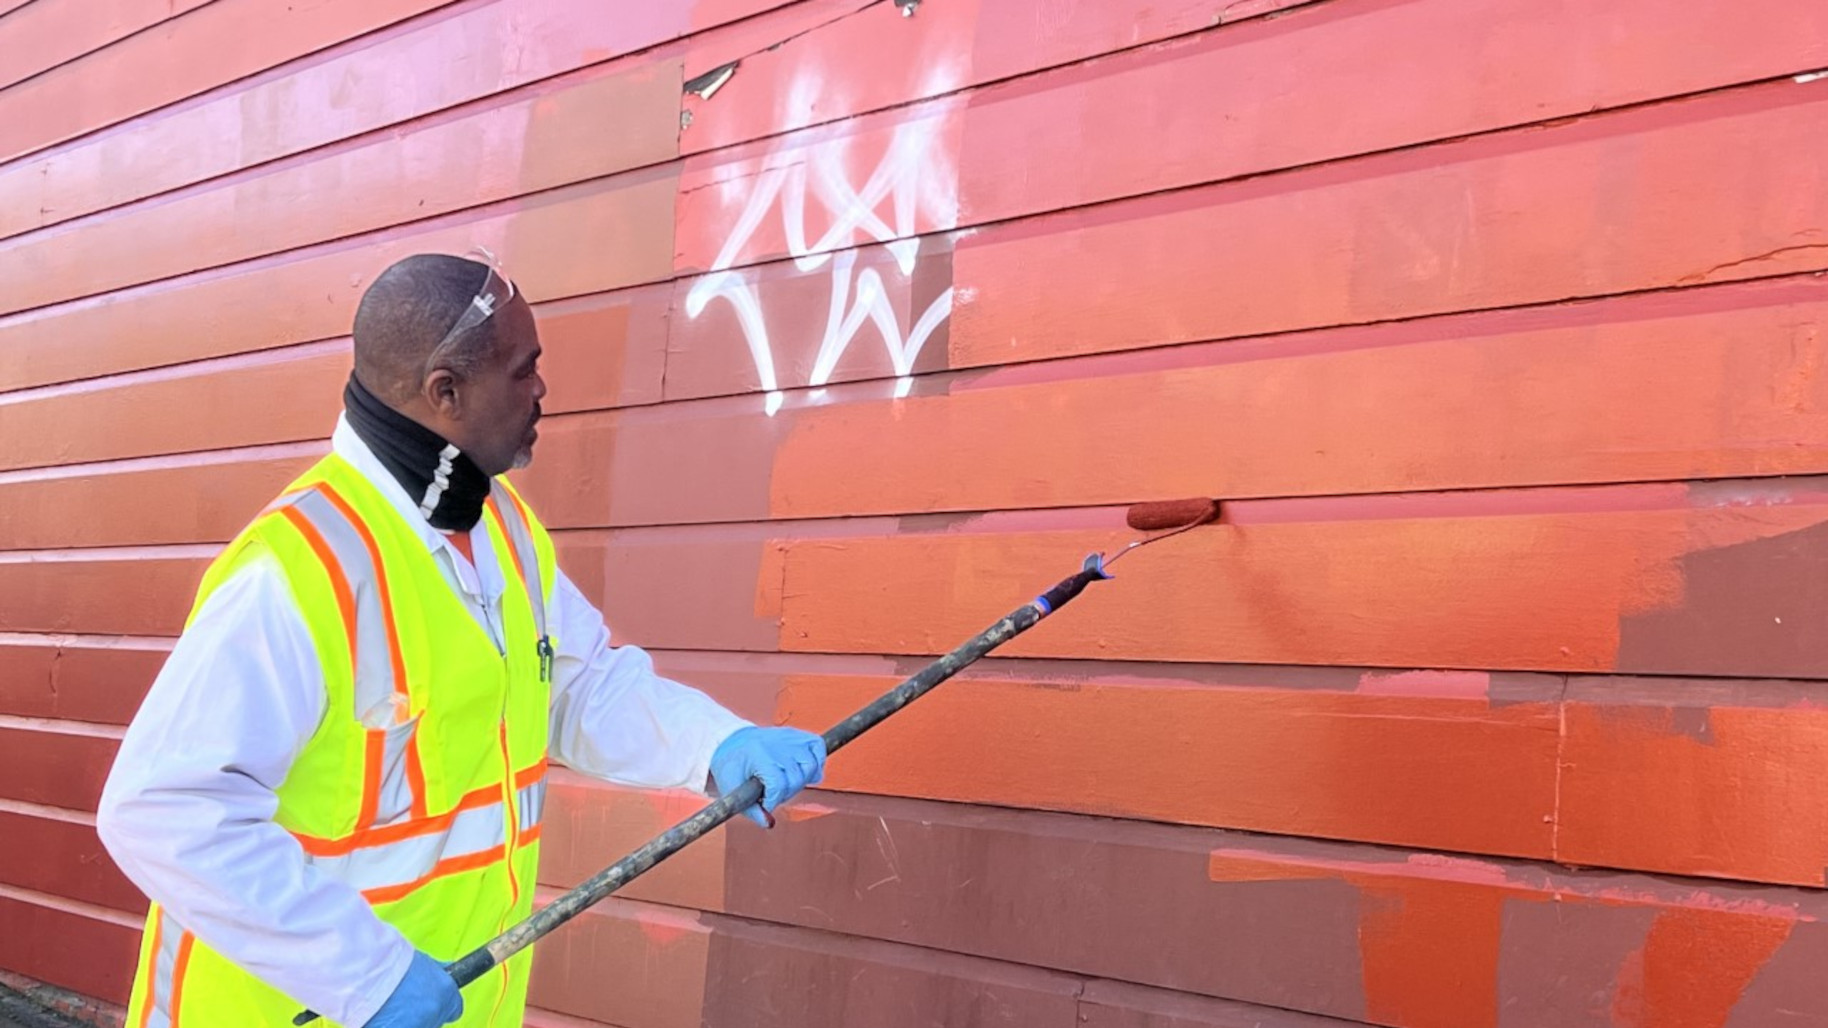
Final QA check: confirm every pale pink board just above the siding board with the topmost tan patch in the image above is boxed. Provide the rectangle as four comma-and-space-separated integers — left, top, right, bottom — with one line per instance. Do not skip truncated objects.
0, 0, 797, 238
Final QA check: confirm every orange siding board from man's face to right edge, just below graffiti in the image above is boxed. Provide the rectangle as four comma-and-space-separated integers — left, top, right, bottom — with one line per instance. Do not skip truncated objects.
511, 276, 1828, 527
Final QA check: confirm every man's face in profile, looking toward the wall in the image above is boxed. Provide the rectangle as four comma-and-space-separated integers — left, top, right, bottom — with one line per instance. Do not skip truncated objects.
448, 296, 547, 477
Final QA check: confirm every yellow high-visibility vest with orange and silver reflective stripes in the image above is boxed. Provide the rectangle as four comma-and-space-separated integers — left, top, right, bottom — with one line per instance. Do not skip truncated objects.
126, 454, 556, 1028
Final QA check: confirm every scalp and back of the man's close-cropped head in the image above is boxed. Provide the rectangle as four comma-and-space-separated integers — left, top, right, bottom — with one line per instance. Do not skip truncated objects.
355, 254, 497, 406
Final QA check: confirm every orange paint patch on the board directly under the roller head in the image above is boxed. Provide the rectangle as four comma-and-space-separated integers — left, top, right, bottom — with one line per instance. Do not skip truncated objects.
781, 488, 1828, 671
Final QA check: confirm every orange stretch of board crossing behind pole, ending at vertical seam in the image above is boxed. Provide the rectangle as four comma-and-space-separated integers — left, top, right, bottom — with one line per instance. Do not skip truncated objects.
777, 675, 1559, 856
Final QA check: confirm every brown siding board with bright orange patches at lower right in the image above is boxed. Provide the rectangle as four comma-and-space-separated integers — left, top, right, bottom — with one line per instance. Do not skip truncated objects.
543, 779, 1828, 1028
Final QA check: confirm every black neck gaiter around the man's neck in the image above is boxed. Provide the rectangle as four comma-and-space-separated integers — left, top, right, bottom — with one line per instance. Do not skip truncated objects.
344, 375, 488, 532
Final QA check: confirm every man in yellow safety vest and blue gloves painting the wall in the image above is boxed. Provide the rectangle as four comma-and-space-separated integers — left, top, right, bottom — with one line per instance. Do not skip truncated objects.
97, 254, 824, 1028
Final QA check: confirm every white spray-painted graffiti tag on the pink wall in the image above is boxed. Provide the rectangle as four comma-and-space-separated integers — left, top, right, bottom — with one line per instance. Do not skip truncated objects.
686, 117, 958, 415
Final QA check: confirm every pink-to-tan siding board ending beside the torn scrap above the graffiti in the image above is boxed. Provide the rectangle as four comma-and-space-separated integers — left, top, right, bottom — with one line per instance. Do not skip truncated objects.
0, 60, 680, 311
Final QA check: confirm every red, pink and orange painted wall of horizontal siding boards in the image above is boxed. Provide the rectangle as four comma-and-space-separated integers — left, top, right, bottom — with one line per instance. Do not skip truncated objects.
0, 0, 1828, 1028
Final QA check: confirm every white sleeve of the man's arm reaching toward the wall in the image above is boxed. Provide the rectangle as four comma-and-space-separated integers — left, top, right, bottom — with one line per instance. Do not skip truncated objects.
548, 573, 749, 792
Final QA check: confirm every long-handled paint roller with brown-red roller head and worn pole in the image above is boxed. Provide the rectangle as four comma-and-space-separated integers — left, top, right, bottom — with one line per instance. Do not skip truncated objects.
292, 499, 1221, 1024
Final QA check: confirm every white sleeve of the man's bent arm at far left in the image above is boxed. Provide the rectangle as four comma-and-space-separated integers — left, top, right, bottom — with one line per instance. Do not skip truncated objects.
97, 562, 418, 1026
